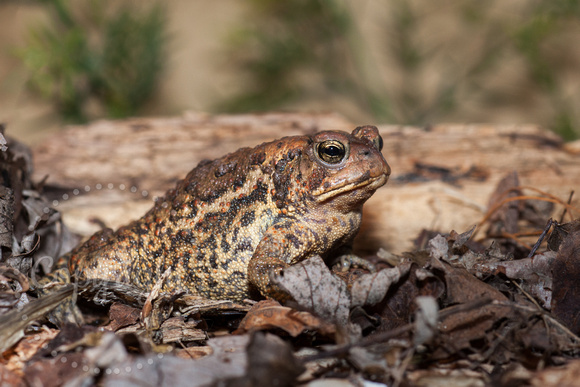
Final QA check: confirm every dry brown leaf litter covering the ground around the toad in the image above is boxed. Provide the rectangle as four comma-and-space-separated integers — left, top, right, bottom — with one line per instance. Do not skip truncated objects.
0, 129, 580, 386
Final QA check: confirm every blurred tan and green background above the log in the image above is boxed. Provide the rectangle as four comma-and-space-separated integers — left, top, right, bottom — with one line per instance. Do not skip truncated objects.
0, 0, 580, 144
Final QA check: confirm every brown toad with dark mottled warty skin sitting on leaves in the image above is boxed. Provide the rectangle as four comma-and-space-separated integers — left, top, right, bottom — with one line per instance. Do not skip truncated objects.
69, 126, 390, 301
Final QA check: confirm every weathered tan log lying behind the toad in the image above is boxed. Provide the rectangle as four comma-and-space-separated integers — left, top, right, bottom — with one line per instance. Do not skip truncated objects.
34, 113, 580, 252
